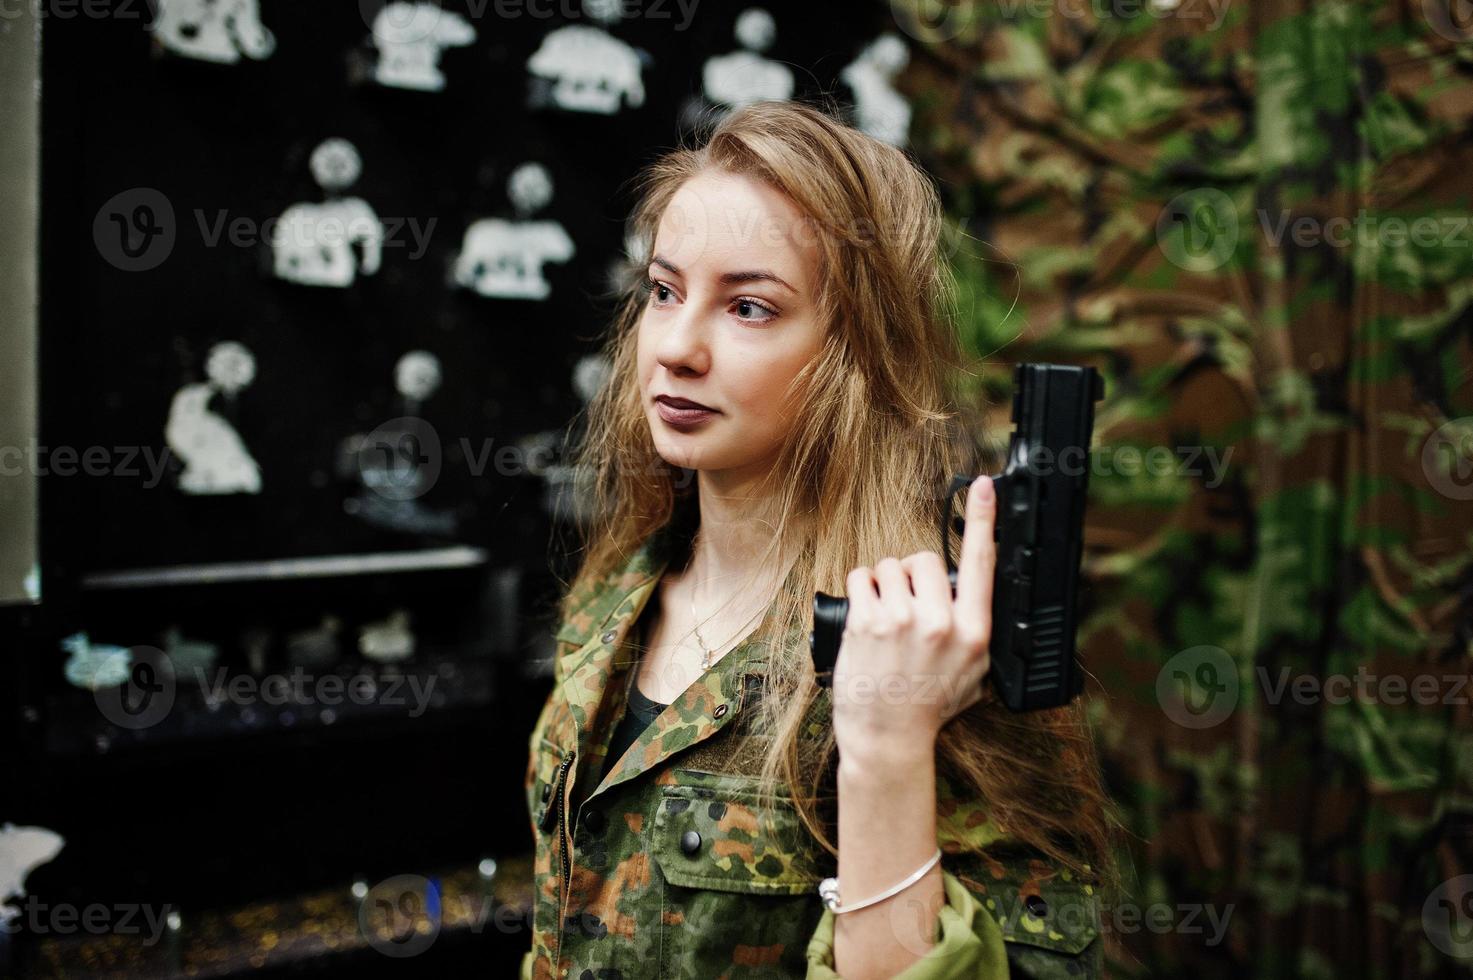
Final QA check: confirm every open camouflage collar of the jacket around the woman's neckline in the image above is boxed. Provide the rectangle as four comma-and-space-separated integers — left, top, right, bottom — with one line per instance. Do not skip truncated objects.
561, 529, 797, 799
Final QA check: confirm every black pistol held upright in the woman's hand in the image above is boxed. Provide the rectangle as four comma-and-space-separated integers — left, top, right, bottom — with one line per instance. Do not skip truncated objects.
809, 364, 1105, 712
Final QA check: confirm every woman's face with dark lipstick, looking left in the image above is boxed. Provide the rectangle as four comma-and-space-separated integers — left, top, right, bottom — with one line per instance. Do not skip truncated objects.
638, 172, 822, 477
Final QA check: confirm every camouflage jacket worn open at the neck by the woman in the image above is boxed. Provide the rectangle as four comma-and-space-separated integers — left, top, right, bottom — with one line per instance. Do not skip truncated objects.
521, 533, 1103, 980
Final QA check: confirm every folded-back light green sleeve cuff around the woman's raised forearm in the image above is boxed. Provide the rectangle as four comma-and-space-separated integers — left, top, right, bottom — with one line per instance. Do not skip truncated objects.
807, 868, 1009, 980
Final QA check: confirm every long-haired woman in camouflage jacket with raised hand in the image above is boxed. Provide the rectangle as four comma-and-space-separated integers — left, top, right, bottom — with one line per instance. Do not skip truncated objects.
523, 103, 1112, 980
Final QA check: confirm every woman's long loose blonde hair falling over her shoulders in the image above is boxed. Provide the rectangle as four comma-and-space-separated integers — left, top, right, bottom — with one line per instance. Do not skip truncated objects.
561, 102, 1115, 887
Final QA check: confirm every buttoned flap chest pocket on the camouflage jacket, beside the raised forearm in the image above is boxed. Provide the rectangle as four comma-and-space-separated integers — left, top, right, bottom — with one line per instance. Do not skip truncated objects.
650, 775, 829, 980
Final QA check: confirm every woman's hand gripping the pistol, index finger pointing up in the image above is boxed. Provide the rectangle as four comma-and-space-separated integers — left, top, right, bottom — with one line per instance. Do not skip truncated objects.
834, 476, 997, 755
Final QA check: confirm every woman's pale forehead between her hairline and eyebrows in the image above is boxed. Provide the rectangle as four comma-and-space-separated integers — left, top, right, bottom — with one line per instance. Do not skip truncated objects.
654, 174, 818, 282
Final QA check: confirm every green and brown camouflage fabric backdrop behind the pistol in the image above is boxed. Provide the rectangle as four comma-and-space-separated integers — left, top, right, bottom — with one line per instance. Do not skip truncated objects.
881, 0, 1473, 980
